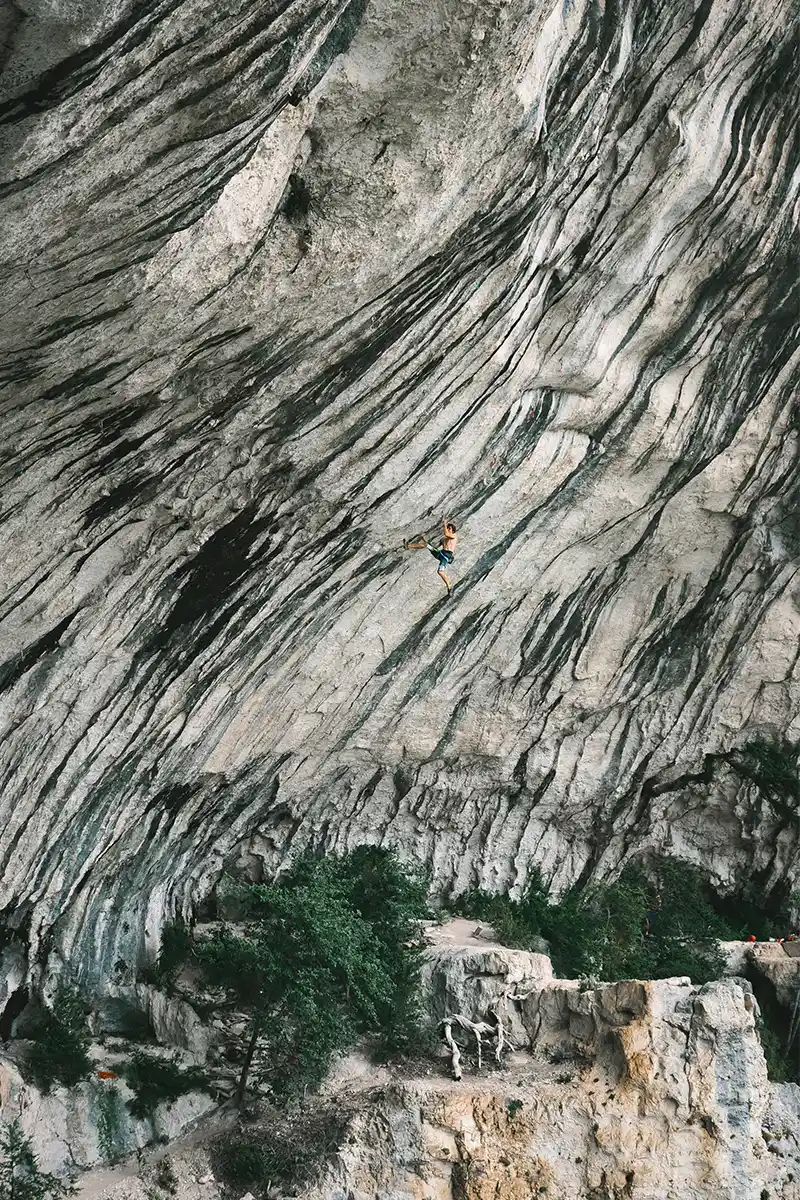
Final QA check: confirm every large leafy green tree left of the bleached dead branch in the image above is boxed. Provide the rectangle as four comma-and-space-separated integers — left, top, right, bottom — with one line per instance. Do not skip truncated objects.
163, 846, 427, 1104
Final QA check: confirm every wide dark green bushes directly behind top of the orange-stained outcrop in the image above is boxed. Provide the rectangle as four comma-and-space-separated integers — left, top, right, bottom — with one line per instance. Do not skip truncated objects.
455, 860, 739, 983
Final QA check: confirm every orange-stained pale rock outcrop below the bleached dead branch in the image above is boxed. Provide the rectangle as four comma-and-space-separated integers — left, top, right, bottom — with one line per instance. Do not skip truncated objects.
307, 964, 800, 1200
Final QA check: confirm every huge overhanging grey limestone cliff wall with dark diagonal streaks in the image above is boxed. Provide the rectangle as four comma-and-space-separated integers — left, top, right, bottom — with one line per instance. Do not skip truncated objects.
0, 0, 800, 979
